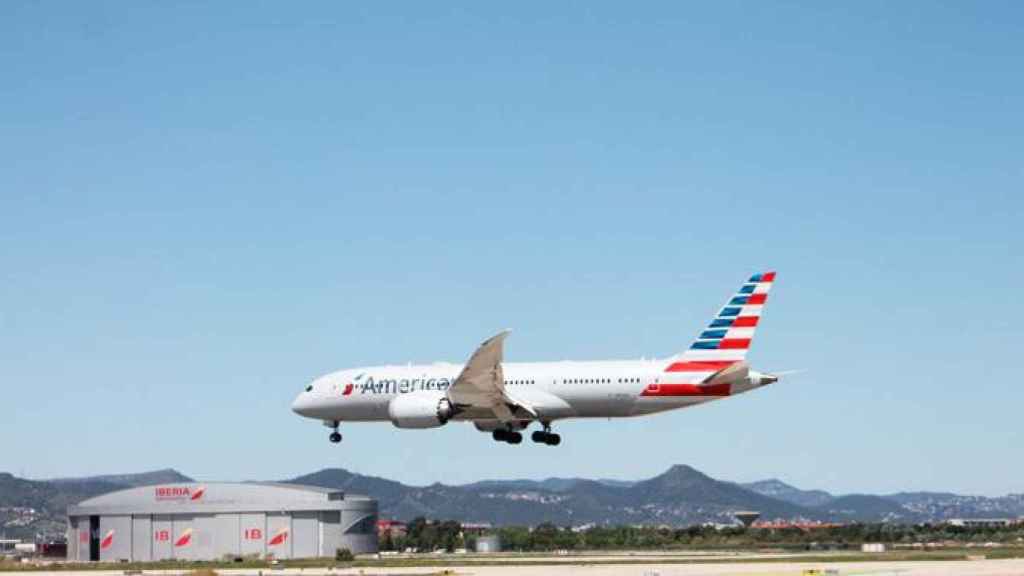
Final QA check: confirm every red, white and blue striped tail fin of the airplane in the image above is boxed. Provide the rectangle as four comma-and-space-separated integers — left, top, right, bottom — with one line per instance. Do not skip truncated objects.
673, 272, 775, 362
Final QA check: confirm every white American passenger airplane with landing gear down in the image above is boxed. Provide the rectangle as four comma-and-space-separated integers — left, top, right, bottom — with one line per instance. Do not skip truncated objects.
292, 272, 778, 446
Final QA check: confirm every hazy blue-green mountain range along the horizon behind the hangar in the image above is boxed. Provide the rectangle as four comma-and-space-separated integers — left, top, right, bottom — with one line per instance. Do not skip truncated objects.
0, 465, 1024, 537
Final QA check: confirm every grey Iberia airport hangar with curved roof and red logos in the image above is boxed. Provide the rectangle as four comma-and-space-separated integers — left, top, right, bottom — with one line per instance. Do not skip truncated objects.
68, 483, 377, 562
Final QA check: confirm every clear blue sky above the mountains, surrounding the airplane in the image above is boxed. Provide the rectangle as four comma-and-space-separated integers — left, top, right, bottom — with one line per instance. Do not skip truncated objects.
0, 2, 1024, 494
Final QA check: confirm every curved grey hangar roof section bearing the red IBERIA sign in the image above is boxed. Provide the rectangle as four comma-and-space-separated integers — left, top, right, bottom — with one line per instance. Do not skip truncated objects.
68, 482, 375, 516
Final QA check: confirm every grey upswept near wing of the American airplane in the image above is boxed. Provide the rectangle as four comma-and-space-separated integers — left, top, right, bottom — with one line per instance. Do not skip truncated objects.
447, 330, 536, 422
